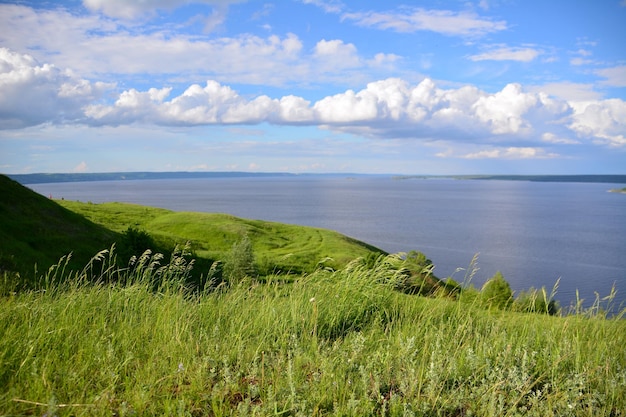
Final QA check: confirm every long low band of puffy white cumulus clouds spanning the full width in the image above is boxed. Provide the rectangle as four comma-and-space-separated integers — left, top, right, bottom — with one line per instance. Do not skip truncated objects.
0, 47, 626, 153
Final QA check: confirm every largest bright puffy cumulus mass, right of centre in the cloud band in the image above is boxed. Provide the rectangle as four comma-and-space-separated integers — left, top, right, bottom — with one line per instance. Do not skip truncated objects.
313, 79, 570, 139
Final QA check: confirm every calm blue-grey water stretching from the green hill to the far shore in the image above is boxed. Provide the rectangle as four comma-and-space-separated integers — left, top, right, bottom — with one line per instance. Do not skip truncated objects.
29, 176, 626, 306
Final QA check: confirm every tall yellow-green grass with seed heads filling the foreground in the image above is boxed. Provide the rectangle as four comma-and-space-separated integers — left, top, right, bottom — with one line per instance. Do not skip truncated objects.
0, 252, 626, 416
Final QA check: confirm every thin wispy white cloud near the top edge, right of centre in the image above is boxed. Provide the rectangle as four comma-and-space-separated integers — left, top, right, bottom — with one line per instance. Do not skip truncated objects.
342, 7, 507, 36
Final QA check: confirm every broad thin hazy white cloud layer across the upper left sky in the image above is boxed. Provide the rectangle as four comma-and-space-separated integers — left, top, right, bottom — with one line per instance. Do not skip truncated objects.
0, 4, 392, 86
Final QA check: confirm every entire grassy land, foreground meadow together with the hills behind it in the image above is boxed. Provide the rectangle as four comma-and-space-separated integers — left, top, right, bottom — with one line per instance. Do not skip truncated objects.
0, 175, 626, 416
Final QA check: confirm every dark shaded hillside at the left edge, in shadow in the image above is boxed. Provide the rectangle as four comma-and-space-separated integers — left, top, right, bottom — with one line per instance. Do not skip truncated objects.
0, 175, 118, 279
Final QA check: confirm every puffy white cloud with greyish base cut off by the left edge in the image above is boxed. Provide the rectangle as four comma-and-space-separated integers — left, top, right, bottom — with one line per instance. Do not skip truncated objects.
0, 48, 112, 129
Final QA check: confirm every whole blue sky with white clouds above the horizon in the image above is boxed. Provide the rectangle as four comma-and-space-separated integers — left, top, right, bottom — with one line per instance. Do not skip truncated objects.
0, 0, 626, 175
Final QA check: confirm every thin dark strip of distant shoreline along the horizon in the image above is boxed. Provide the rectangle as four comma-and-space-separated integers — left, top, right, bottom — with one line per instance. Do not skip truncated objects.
7, 171, 626, 185
